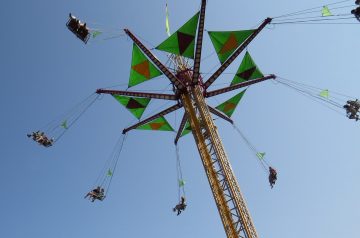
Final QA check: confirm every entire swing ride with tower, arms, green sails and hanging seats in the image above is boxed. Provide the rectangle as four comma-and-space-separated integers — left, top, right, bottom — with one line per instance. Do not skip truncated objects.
28, 0, 360, 238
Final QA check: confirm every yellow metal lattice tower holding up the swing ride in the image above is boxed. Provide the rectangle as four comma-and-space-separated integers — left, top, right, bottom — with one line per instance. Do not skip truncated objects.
177, 66, 258, 238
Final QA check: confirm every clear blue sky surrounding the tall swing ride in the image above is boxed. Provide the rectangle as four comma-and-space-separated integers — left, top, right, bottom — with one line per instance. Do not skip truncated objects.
0, 0, 360, 238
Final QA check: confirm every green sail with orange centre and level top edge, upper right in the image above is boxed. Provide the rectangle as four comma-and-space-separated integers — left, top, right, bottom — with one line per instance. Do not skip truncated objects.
208, 30, 255, 64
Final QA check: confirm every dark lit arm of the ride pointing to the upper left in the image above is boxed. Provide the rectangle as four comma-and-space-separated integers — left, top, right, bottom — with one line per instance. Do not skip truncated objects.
124, 29, 185, 91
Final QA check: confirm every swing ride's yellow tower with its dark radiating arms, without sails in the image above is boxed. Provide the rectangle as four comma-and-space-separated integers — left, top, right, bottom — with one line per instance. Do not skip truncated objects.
97, 0, 275, 238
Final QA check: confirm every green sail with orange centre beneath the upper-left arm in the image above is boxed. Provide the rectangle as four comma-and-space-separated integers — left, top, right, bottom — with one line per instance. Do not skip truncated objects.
129, 44, 162, 87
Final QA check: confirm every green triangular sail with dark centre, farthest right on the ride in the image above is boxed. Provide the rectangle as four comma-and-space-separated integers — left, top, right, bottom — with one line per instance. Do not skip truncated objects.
231, 52, 264, 85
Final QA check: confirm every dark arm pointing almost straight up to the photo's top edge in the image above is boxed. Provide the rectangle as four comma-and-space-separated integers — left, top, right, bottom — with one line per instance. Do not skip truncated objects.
192, 0, 206, 84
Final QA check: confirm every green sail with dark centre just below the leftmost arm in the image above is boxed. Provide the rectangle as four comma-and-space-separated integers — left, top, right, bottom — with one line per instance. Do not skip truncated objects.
112, 95, 151, 119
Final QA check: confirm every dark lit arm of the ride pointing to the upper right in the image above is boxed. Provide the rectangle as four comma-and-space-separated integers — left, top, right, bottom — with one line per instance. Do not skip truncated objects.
204, 18, 272, 89
